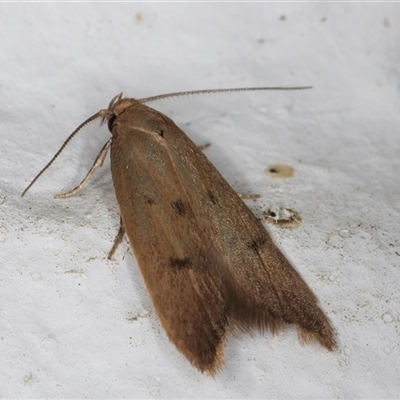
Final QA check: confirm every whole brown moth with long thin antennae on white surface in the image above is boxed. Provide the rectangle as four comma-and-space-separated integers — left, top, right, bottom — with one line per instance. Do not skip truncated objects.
22, 88, 335, 374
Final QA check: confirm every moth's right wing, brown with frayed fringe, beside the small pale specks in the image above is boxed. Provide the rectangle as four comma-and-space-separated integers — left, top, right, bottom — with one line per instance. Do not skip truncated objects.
166, 115, 335, 350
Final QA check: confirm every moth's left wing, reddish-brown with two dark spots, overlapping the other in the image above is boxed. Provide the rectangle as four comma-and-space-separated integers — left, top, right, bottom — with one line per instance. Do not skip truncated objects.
111, 110, 229, 374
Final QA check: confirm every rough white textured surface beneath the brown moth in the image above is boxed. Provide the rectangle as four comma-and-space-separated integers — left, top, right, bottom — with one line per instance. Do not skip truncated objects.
0, 3, 400, 398
